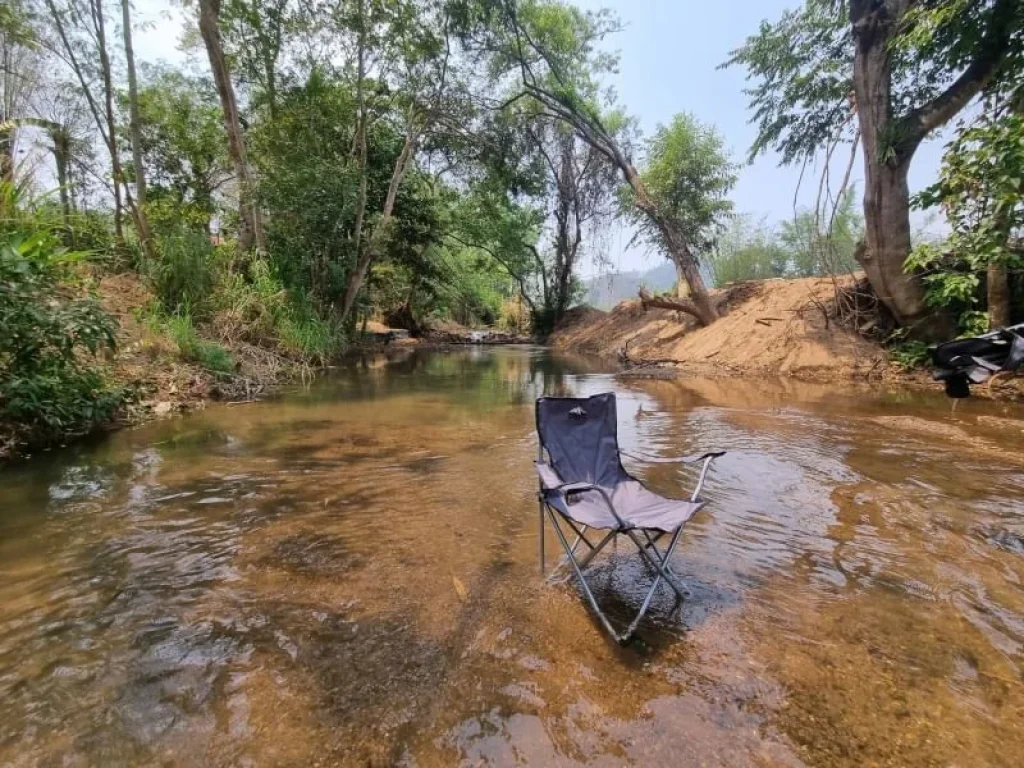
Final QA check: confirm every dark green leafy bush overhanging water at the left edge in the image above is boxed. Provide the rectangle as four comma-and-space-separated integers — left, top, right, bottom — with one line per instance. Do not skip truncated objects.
0, 221, 128, 442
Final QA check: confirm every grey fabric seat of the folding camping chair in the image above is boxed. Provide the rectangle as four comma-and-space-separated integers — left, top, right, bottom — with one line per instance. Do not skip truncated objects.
544, 478, 705, 534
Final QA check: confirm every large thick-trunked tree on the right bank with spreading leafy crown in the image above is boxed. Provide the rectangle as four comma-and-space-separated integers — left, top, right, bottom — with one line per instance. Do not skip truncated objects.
726, 0, 1024, 337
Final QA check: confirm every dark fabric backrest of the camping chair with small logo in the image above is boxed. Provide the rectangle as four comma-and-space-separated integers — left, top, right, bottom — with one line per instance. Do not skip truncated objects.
537, 392, 629, 487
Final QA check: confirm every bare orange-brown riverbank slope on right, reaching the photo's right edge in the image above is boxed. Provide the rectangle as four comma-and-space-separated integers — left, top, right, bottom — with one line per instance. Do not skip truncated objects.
548, 278, 1024, 398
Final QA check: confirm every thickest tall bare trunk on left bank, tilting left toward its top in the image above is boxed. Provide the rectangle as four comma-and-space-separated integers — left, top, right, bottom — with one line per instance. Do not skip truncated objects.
199, 0, 266, 252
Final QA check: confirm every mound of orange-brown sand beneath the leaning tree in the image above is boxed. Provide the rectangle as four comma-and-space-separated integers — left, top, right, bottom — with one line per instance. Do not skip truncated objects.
549, 278, 885, 378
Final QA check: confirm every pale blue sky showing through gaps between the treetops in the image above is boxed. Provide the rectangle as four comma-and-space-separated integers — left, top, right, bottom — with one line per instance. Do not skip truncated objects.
136, 0, 942, 275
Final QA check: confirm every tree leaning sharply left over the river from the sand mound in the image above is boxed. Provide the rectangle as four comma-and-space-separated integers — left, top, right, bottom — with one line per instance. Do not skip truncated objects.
468, 0, 718, 325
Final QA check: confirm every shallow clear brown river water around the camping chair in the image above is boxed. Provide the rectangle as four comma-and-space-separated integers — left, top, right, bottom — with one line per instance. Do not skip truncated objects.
0, 347, 1024, 766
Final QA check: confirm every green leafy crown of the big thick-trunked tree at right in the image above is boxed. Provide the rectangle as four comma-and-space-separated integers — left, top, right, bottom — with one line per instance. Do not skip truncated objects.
723, 0, 1024, 163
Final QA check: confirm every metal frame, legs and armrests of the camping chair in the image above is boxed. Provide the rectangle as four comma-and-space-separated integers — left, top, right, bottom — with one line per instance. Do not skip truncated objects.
537, 434, 725, 643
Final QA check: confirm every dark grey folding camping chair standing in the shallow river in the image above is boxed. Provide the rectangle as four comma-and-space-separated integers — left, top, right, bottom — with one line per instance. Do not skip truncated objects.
537, 392, 724, 643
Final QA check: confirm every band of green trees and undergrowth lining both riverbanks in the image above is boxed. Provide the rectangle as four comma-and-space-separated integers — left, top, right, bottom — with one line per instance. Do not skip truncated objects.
0, 0, 1024, 450
